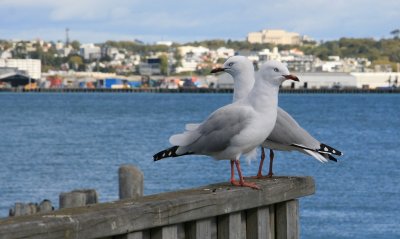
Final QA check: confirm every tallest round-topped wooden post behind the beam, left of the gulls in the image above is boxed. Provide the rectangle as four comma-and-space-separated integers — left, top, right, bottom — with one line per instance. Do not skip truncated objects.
118, 164, 143, 199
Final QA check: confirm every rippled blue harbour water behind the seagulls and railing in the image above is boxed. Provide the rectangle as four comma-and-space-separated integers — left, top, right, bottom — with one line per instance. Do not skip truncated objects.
0, 93, 400, 238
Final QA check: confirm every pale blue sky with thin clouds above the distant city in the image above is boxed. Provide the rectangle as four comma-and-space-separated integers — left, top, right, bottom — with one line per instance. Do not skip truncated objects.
0, 0, 400, 44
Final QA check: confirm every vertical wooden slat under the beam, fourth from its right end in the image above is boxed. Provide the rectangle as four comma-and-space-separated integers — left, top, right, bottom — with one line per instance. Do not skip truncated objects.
185, 217, 217, 239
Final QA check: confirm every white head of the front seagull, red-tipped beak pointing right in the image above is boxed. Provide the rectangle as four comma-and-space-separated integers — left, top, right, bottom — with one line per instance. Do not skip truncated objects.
258, 61, 299, 86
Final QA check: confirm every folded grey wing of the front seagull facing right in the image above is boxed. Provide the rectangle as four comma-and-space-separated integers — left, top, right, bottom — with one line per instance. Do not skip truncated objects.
185, 105, 250, 154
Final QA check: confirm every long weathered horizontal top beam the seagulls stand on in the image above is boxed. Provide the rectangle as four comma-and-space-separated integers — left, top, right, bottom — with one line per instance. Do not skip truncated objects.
0, 177, 315, 239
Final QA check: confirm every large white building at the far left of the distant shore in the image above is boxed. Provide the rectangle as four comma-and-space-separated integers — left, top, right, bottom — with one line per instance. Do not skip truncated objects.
0, 59, 42, 79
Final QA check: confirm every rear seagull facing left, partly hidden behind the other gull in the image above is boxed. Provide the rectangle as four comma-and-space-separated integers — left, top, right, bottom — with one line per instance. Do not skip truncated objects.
211, 56, 343, 178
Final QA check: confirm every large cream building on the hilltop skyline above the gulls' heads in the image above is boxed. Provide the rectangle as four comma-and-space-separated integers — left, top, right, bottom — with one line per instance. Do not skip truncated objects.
247, 30, 302, 45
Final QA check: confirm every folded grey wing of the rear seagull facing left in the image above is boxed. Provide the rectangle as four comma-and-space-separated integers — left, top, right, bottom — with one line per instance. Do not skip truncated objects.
267, 107, 320, 149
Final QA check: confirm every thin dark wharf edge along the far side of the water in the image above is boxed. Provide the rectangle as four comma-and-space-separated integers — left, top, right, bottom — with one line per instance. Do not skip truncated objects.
0, 87, 400, 94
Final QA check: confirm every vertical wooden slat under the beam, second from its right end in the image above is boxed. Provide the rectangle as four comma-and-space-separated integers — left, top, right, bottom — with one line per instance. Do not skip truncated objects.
246, 207, 271, 239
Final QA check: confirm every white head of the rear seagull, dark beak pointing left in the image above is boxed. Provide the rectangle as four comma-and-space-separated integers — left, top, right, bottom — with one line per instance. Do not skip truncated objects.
211, 56, 254, 77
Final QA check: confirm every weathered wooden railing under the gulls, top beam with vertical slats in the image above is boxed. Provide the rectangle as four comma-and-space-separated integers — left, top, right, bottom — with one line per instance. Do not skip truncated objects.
0, 177, 315, 239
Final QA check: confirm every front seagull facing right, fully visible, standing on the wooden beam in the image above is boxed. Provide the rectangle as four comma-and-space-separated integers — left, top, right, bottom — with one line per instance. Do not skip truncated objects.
153, 61, 299, 189
